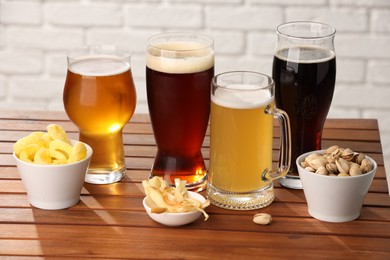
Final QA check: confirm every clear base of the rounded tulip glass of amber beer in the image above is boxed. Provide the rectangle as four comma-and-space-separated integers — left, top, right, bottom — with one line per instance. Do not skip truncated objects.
85, 167, 126, 184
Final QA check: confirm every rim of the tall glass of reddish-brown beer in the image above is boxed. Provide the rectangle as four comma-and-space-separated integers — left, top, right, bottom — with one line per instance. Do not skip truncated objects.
146, 32, 214, 52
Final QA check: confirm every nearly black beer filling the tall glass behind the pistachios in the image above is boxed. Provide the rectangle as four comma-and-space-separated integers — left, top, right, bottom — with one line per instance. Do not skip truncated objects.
272, 47, 336, 174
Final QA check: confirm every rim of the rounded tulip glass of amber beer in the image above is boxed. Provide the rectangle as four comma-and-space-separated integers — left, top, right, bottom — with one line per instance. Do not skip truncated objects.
66, 44, 132, 61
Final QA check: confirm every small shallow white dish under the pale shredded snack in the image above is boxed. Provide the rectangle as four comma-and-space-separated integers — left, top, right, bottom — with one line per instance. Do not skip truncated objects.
142, 191, 206, 226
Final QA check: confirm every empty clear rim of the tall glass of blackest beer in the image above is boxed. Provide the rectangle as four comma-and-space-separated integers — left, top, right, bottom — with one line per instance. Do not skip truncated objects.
276, 21, 336, 40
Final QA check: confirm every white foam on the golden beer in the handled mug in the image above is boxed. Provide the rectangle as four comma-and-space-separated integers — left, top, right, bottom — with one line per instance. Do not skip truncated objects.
211, 84, 273, 109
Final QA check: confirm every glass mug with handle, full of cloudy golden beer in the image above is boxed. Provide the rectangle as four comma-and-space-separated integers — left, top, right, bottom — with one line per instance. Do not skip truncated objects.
207, 71, 290, 210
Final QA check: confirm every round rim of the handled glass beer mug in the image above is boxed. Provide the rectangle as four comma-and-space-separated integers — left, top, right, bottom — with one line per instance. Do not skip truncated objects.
211, 70, 275, 92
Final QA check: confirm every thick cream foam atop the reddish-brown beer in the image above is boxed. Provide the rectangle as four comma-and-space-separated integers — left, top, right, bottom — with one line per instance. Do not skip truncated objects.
146, 42, 214, 74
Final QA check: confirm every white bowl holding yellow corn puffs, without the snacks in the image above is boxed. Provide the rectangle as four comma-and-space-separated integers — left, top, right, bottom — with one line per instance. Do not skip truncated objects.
13, 140, 92, 210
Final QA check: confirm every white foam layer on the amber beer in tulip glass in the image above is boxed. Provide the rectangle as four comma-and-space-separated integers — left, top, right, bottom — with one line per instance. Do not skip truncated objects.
69, 55, 130, 77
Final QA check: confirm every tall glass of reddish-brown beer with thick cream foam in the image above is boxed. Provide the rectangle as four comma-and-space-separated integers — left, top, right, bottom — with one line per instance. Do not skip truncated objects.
146, 33, 214, 191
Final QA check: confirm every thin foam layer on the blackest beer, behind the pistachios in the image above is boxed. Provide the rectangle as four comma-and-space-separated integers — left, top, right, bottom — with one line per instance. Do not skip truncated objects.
275, 46, 336, 63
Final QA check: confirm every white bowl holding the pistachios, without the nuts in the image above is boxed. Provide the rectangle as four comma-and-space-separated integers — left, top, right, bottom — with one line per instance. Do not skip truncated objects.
296, 150, 377, 222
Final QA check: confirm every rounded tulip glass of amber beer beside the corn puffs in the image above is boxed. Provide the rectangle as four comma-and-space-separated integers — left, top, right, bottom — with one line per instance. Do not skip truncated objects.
63, 45, 136, 184
